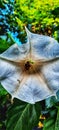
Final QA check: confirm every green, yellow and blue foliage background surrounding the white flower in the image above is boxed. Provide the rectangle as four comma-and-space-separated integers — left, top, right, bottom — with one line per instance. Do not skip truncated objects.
0, 0, 59, 130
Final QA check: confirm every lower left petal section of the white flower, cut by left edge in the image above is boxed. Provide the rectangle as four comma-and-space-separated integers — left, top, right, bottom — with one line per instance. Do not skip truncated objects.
0, 60, 22, 95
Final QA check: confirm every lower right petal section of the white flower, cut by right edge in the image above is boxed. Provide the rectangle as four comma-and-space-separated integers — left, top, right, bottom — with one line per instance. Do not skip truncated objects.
42, 60, 59, 94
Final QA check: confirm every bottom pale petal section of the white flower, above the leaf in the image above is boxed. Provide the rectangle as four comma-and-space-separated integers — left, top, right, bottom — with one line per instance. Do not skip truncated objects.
12, 76, 54, 104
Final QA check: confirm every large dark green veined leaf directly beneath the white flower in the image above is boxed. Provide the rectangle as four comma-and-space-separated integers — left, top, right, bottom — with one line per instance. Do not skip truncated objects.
7, 100, 41, 130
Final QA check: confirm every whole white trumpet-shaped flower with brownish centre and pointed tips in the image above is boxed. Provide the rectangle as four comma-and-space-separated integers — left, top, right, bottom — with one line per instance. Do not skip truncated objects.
0, 28, 59, 104
